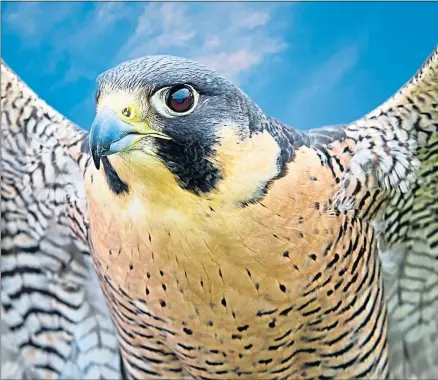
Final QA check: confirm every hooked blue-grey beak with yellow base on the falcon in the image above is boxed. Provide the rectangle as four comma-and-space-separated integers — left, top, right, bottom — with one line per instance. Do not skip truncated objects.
89, 107, 169, 170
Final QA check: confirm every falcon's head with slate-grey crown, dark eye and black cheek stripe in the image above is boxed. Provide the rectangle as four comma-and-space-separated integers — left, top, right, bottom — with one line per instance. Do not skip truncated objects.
90, 56, 302, 208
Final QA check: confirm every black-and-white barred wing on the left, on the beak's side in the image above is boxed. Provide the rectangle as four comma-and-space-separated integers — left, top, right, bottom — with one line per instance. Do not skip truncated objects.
1, 61, 120, 379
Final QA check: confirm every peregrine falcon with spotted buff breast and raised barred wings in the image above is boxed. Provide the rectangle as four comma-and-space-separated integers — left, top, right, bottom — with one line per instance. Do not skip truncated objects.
1, 48, 438, 379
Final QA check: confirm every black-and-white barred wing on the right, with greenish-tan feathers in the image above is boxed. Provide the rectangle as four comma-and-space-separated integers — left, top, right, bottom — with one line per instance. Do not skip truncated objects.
316, 47, 438, 379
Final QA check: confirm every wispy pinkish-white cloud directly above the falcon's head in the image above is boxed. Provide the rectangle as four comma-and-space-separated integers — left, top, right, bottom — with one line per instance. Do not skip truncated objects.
116, 3, 287, 81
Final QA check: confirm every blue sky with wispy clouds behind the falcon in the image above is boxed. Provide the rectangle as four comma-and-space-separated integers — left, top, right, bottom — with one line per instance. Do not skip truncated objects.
1, 1, 438, 129
